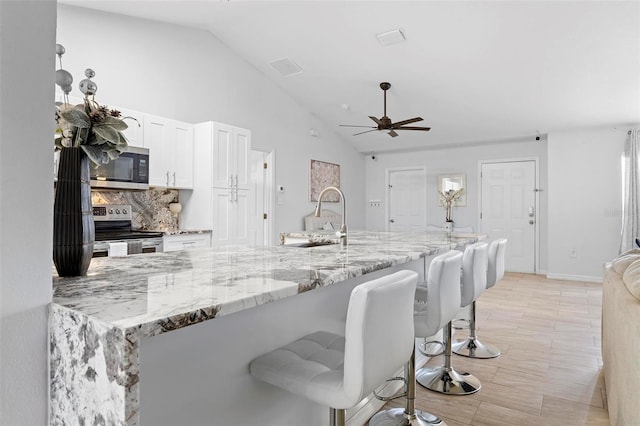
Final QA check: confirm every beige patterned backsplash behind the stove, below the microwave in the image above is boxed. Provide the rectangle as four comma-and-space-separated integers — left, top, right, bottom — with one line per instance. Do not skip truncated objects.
91, 189, 179, 232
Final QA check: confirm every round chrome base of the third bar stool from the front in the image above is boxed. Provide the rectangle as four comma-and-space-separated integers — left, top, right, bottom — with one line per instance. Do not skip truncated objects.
416, 366, 480, 395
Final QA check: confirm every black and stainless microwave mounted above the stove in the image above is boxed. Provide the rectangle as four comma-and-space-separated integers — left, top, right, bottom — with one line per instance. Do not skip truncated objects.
91, 146, 149, 190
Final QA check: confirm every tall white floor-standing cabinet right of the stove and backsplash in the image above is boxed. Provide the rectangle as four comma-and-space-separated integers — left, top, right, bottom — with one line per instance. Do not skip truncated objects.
181, 122, 251, 245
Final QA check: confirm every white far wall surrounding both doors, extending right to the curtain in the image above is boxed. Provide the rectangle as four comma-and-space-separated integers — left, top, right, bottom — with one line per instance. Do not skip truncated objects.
366, 127, 626, 281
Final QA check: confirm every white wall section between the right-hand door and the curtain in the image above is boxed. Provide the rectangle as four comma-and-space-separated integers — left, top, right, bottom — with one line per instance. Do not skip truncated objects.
548, 128, 626, 281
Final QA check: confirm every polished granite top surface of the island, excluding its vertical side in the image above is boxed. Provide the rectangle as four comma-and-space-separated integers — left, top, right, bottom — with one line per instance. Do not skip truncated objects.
53, 231, 478, 337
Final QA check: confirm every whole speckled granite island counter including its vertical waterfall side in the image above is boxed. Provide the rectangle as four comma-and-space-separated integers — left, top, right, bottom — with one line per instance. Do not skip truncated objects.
50, 231, 482, 425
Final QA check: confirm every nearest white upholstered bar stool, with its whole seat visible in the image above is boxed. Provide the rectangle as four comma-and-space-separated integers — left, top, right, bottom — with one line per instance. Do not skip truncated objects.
249, 271, 418, 426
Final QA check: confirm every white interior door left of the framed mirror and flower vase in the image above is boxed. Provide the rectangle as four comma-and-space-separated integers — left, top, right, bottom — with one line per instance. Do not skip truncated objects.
387, 168, 427, 231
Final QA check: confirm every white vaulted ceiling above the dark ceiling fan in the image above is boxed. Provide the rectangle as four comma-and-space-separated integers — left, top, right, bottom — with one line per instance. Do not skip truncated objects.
60, 0, 640, 152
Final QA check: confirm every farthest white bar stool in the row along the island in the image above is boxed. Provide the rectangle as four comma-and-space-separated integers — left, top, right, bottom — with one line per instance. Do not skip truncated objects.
452, 238, 507, 359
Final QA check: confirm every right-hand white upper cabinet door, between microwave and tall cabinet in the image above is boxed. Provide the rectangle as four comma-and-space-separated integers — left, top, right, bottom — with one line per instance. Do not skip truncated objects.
167, 121, 193, 189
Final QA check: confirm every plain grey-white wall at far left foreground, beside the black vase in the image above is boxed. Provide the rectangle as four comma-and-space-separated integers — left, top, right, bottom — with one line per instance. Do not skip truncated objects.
0, 0, 56, 426
